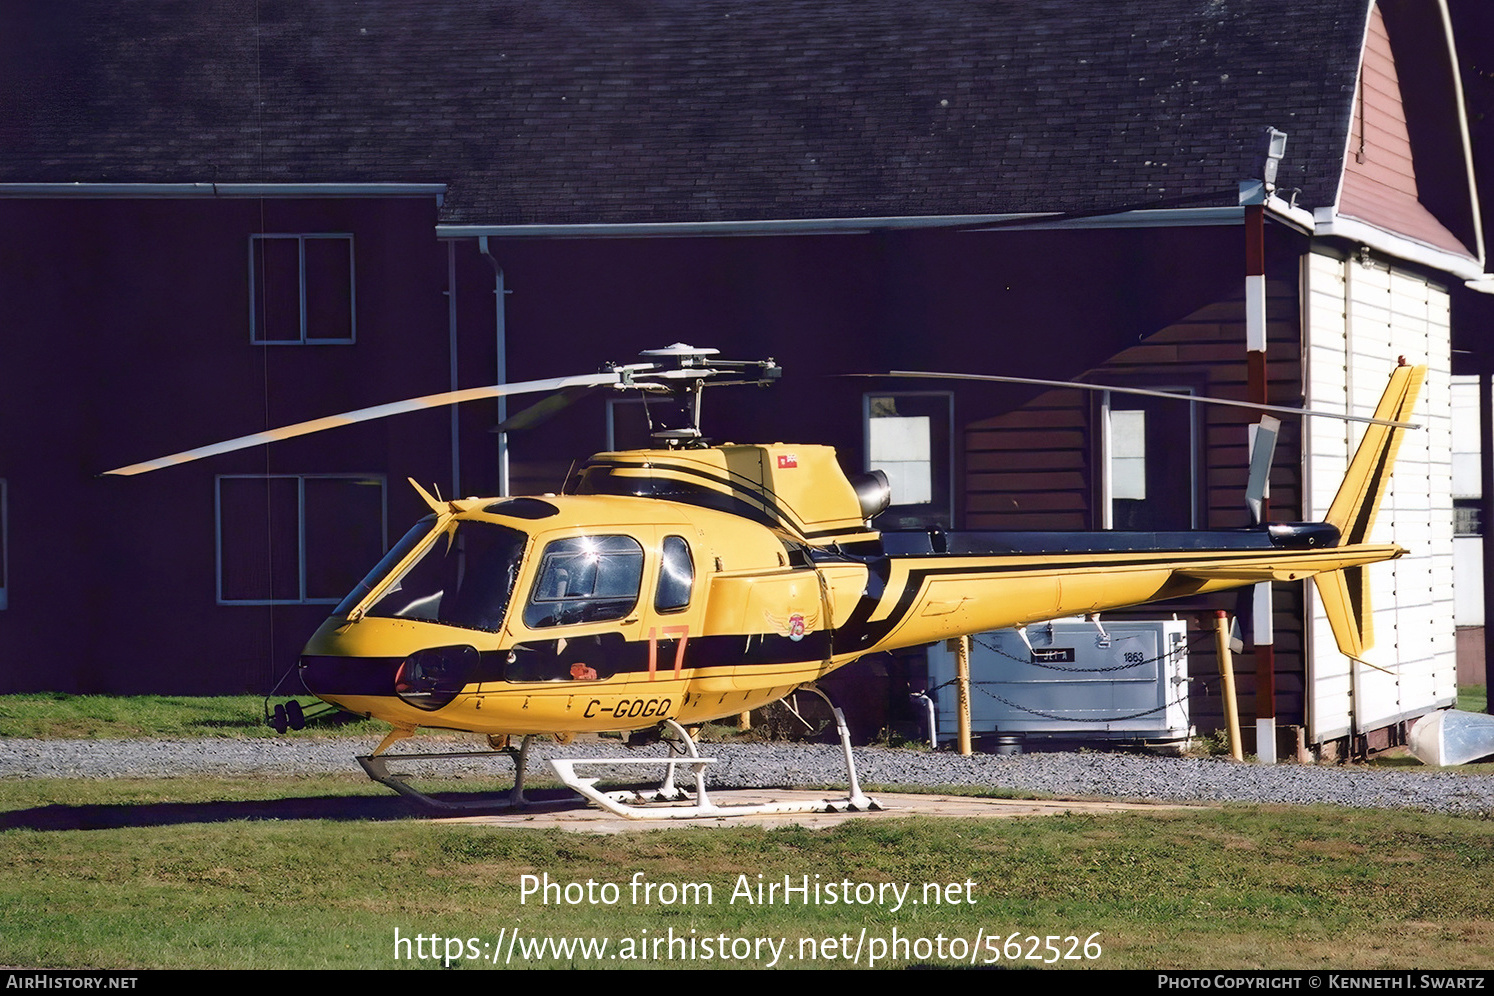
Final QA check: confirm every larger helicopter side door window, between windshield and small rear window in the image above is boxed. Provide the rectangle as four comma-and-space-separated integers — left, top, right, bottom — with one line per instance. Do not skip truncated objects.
524, 536, 644, 629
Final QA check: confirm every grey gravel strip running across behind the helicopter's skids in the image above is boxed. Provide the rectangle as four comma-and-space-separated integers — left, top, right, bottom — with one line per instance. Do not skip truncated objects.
0, 738, 1494, 817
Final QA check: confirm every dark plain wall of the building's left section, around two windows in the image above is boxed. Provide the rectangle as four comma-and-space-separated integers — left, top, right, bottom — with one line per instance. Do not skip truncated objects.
0, 197, 450, 694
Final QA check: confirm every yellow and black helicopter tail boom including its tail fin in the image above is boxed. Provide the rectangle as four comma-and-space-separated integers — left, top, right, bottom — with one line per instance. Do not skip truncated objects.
835, 366, 1425, 663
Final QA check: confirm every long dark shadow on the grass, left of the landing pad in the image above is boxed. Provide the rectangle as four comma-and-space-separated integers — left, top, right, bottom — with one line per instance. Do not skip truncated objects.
0, 788, 580, 830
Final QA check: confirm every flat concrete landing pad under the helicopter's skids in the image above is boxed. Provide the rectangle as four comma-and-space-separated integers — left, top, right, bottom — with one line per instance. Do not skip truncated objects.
441, 788, 1198, 833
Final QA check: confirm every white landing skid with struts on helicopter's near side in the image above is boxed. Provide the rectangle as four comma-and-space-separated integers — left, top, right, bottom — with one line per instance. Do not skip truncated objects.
550, 687, 881, 820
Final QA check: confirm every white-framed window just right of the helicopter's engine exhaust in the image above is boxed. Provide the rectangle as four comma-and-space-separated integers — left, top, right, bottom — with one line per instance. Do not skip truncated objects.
862, 391, 955, 527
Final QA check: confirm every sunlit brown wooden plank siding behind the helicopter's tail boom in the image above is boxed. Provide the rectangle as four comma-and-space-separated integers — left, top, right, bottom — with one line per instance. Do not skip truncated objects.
964, 276, 1306, 730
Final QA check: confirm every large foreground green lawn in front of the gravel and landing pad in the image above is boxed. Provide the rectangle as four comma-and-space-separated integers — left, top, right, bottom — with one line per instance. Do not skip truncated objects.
0, 776, 1494, 969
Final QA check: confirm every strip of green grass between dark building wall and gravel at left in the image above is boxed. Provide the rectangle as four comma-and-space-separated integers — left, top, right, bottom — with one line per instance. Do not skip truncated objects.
0, 693, 388, 739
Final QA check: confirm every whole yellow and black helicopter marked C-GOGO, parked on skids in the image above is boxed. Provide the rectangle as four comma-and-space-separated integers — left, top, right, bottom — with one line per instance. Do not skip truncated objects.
108, 343, 1424, 818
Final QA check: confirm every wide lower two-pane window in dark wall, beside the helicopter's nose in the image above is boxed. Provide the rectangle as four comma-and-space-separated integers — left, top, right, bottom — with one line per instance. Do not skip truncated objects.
217, 475, 387, 605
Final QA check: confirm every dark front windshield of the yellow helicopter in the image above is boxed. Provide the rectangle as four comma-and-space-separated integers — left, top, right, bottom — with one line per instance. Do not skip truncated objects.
336, 517, 527, 633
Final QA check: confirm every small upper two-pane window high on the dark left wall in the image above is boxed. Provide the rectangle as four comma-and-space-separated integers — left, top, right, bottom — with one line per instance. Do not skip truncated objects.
249, 233, 357, 345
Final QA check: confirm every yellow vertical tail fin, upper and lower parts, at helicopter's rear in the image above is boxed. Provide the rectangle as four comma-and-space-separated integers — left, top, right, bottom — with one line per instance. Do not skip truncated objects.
1313, 366, 1427, 660
